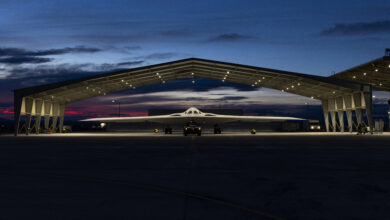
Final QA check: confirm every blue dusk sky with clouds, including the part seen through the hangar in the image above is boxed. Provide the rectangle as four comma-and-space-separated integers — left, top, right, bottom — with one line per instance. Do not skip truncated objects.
0, 0, 390, 118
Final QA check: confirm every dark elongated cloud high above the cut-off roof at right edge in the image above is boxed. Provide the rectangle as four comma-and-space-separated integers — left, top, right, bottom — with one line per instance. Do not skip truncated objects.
321, 20, 390, 36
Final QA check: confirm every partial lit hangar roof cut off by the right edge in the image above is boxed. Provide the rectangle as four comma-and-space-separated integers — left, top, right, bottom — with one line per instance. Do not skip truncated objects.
331, 56, 390, 91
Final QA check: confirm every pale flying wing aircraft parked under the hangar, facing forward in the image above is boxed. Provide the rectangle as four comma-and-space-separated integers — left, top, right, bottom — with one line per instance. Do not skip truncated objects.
82, 107, 304, 135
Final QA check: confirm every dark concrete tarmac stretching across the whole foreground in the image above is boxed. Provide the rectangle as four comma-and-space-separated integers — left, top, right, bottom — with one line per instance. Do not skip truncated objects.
0, 133, 390, 220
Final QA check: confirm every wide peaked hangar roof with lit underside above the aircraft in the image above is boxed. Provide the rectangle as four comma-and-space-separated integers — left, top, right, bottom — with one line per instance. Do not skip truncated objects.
14, 58, 368, 104
